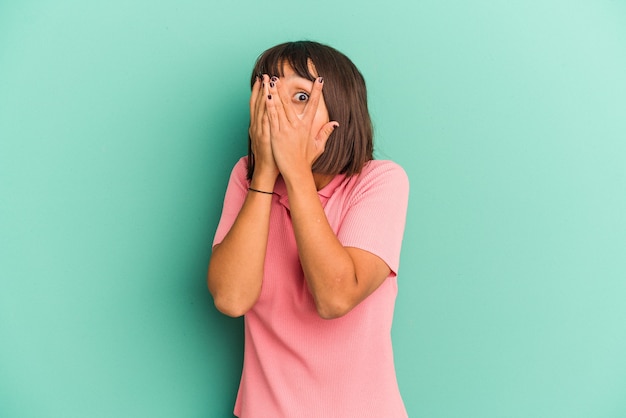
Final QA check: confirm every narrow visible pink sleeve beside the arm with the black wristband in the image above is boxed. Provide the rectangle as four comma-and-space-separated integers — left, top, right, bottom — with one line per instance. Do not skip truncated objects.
213, 157, 248, 246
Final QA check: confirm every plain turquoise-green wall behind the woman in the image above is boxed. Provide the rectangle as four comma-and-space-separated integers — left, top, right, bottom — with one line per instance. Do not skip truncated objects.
0, 0, 626, 418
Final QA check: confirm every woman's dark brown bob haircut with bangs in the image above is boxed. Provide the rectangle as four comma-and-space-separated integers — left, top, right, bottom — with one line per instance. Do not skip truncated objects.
248, 41, 374, 180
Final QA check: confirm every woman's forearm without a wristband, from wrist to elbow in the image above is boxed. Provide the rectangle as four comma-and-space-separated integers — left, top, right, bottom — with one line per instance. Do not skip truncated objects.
286, 172, 358, 318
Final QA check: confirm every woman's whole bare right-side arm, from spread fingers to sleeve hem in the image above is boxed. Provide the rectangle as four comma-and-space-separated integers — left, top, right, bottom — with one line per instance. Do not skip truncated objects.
267, 79, 390, 318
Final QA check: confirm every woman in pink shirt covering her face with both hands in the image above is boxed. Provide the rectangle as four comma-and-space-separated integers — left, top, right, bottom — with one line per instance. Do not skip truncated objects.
208, 41, 409, 418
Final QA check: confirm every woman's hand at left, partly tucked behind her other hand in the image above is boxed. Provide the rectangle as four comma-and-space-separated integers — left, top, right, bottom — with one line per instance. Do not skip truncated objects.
248, 74, 278, 183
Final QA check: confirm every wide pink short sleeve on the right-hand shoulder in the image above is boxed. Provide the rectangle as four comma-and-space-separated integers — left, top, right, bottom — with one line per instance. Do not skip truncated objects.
337, 160, 409, 274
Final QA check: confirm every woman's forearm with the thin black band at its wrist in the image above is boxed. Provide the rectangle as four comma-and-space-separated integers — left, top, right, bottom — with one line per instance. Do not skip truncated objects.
208, 176, 273, 316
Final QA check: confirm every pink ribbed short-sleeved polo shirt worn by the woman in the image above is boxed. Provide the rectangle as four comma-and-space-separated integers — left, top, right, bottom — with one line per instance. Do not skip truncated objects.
214, 157, 409, 418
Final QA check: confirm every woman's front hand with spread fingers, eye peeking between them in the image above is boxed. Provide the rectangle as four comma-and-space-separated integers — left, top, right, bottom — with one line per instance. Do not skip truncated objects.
266, 77, 339, 176
